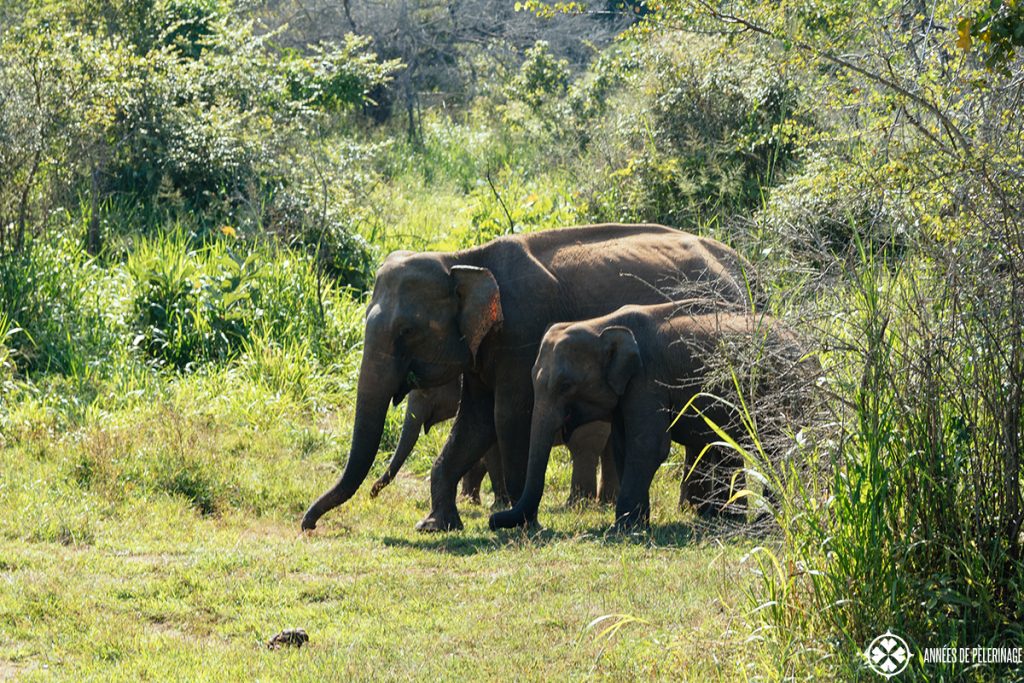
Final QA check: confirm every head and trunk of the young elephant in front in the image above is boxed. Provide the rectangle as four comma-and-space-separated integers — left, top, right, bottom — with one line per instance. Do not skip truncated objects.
490, 323, 643, 528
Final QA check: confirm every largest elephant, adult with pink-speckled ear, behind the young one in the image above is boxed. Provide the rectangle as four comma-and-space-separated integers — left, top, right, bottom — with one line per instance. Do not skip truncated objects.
302, 224, 748, 531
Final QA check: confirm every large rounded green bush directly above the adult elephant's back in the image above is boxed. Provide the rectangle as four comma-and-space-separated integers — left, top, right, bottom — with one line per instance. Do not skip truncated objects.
580, 32, 798, 226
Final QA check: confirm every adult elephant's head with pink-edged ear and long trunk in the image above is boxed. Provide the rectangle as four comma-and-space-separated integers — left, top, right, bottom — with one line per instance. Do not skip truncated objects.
302, 252, 503, 529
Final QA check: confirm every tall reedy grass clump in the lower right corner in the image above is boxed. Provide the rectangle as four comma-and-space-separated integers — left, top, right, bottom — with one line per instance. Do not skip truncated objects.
755, 236, 1024, 680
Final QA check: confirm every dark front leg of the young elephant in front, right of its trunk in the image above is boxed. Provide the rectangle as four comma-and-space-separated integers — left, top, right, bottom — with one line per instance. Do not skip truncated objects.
615, 411, 671, 529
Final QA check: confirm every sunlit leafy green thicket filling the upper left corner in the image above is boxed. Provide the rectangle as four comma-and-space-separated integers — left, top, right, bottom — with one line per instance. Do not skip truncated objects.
0, 0, 398, 258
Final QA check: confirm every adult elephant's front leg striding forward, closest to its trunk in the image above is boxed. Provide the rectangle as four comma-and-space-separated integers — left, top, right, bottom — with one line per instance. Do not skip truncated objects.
416, 375, 495, 531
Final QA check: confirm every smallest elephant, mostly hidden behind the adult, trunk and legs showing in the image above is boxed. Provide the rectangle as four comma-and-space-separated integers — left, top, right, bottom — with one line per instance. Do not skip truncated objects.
370, 378, 618, 509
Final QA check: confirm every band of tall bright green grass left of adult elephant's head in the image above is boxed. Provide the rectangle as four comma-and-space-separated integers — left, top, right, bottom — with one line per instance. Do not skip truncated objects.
0, 218, 369, 389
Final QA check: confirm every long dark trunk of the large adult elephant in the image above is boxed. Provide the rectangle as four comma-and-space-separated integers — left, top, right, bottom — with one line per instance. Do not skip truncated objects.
302, 355, 401, 529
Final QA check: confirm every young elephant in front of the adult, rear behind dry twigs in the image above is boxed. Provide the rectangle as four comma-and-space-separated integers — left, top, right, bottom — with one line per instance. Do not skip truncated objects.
490, 303, 801, 529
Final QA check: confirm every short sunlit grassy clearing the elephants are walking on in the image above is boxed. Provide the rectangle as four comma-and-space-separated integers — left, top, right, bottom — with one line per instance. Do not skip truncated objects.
0, 387, 757, 680
